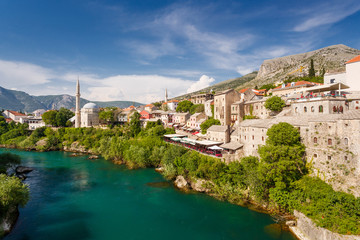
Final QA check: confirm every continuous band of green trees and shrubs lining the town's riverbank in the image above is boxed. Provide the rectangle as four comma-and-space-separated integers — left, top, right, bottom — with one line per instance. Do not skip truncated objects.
0, 115, 360, 234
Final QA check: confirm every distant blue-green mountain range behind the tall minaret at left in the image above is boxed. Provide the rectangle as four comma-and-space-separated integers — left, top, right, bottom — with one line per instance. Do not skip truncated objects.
0, 87, 142, 112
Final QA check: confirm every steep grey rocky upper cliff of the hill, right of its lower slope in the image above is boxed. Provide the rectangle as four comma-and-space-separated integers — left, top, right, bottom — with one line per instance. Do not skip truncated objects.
242, 44, 360, 87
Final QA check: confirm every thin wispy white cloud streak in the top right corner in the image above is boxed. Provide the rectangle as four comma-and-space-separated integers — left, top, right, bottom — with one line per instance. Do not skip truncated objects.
294, 0, 360, 32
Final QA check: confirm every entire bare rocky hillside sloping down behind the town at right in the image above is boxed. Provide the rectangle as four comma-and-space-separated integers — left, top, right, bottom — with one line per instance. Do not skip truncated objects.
176, 44, 360, 96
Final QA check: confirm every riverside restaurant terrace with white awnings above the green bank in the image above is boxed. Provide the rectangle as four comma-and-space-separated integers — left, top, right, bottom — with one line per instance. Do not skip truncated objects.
164, 134, 224, 158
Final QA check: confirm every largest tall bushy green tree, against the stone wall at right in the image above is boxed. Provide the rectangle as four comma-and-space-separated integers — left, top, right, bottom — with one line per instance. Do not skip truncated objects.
258, 122, 307, 200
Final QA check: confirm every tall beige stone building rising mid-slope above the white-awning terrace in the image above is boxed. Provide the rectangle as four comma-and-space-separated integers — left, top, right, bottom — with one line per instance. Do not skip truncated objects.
214, 89, 241, 126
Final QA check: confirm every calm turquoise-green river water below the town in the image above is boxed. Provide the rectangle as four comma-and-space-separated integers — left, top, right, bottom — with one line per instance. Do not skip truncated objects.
0, 149, 295, 240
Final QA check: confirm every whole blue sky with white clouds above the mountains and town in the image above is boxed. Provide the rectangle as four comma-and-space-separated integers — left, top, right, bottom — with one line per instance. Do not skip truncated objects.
0, 0, 360, 103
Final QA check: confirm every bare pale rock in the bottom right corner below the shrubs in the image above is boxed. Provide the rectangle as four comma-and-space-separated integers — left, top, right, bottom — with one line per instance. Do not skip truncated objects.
290, 210, 360, 240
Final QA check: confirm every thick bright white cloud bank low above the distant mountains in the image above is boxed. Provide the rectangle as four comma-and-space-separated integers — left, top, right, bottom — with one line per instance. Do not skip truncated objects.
0, 60, 215, 103
